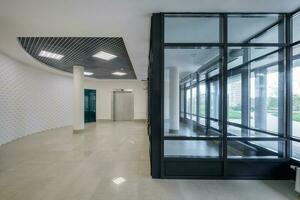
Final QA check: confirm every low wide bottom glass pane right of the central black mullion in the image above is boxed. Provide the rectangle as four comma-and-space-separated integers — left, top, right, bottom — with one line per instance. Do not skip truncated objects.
227, 141, 284, 159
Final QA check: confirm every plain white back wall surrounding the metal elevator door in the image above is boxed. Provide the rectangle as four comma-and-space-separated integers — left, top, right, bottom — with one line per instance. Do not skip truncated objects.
84, 79, 147, 119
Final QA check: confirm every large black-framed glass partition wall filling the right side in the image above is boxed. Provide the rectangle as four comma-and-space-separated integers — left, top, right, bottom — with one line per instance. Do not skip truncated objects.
149, 13, 300, 179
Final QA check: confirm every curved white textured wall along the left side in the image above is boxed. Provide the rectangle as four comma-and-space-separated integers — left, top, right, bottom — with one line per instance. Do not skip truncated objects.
0, 54, 73, 145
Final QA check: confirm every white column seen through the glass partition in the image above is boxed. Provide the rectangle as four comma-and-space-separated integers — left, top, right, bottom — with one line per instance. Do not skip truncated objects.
169, 67, 179, 133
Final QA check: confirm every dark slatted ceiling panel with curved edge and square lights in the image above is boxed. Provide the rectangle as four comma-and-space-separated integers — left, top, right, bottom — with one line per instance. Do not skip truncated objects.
18, 37, 136, 79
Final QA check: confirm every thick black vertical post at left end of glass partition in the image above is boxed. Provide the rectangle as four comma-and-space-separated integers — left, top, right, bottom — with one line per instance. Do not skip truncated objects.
148, 14, 164, 178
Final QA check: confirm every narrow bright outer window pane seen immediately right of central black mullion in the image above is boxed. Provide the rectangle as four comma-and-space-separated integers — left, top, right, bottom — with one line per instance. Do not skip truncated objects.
227, 74, 242, 124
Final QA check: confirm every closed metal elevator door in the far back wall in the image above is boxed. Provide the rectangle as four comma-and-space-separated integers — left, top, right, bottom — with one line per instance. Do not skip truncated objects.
113, 91, 134, 121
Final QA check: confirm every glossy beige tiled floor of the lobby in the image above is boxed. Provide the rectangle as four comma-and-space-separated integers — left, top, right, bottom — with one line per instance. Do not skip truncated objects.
0, 121, 297, 200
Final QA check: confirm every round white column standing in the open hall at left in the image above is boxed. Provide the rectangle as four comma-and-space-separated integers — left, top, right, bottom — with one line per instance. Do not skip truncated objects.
73, 66, 84, 133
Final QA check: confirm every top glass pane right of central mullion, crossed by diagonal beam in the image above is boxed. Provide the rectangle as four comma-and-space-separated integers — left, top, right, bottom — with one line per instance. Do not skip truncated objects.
228, 14, 282, 43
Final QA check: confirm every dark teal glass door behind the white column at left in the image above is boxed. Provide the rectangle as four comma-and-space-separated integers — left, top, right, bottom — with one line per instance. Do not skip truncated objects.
84, 89, 96, 123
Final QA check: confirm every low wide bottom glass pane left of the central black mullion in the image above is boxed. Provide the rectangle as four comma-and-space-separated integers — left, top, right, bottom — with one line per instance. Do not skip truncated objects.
164, 140, 220, 157
